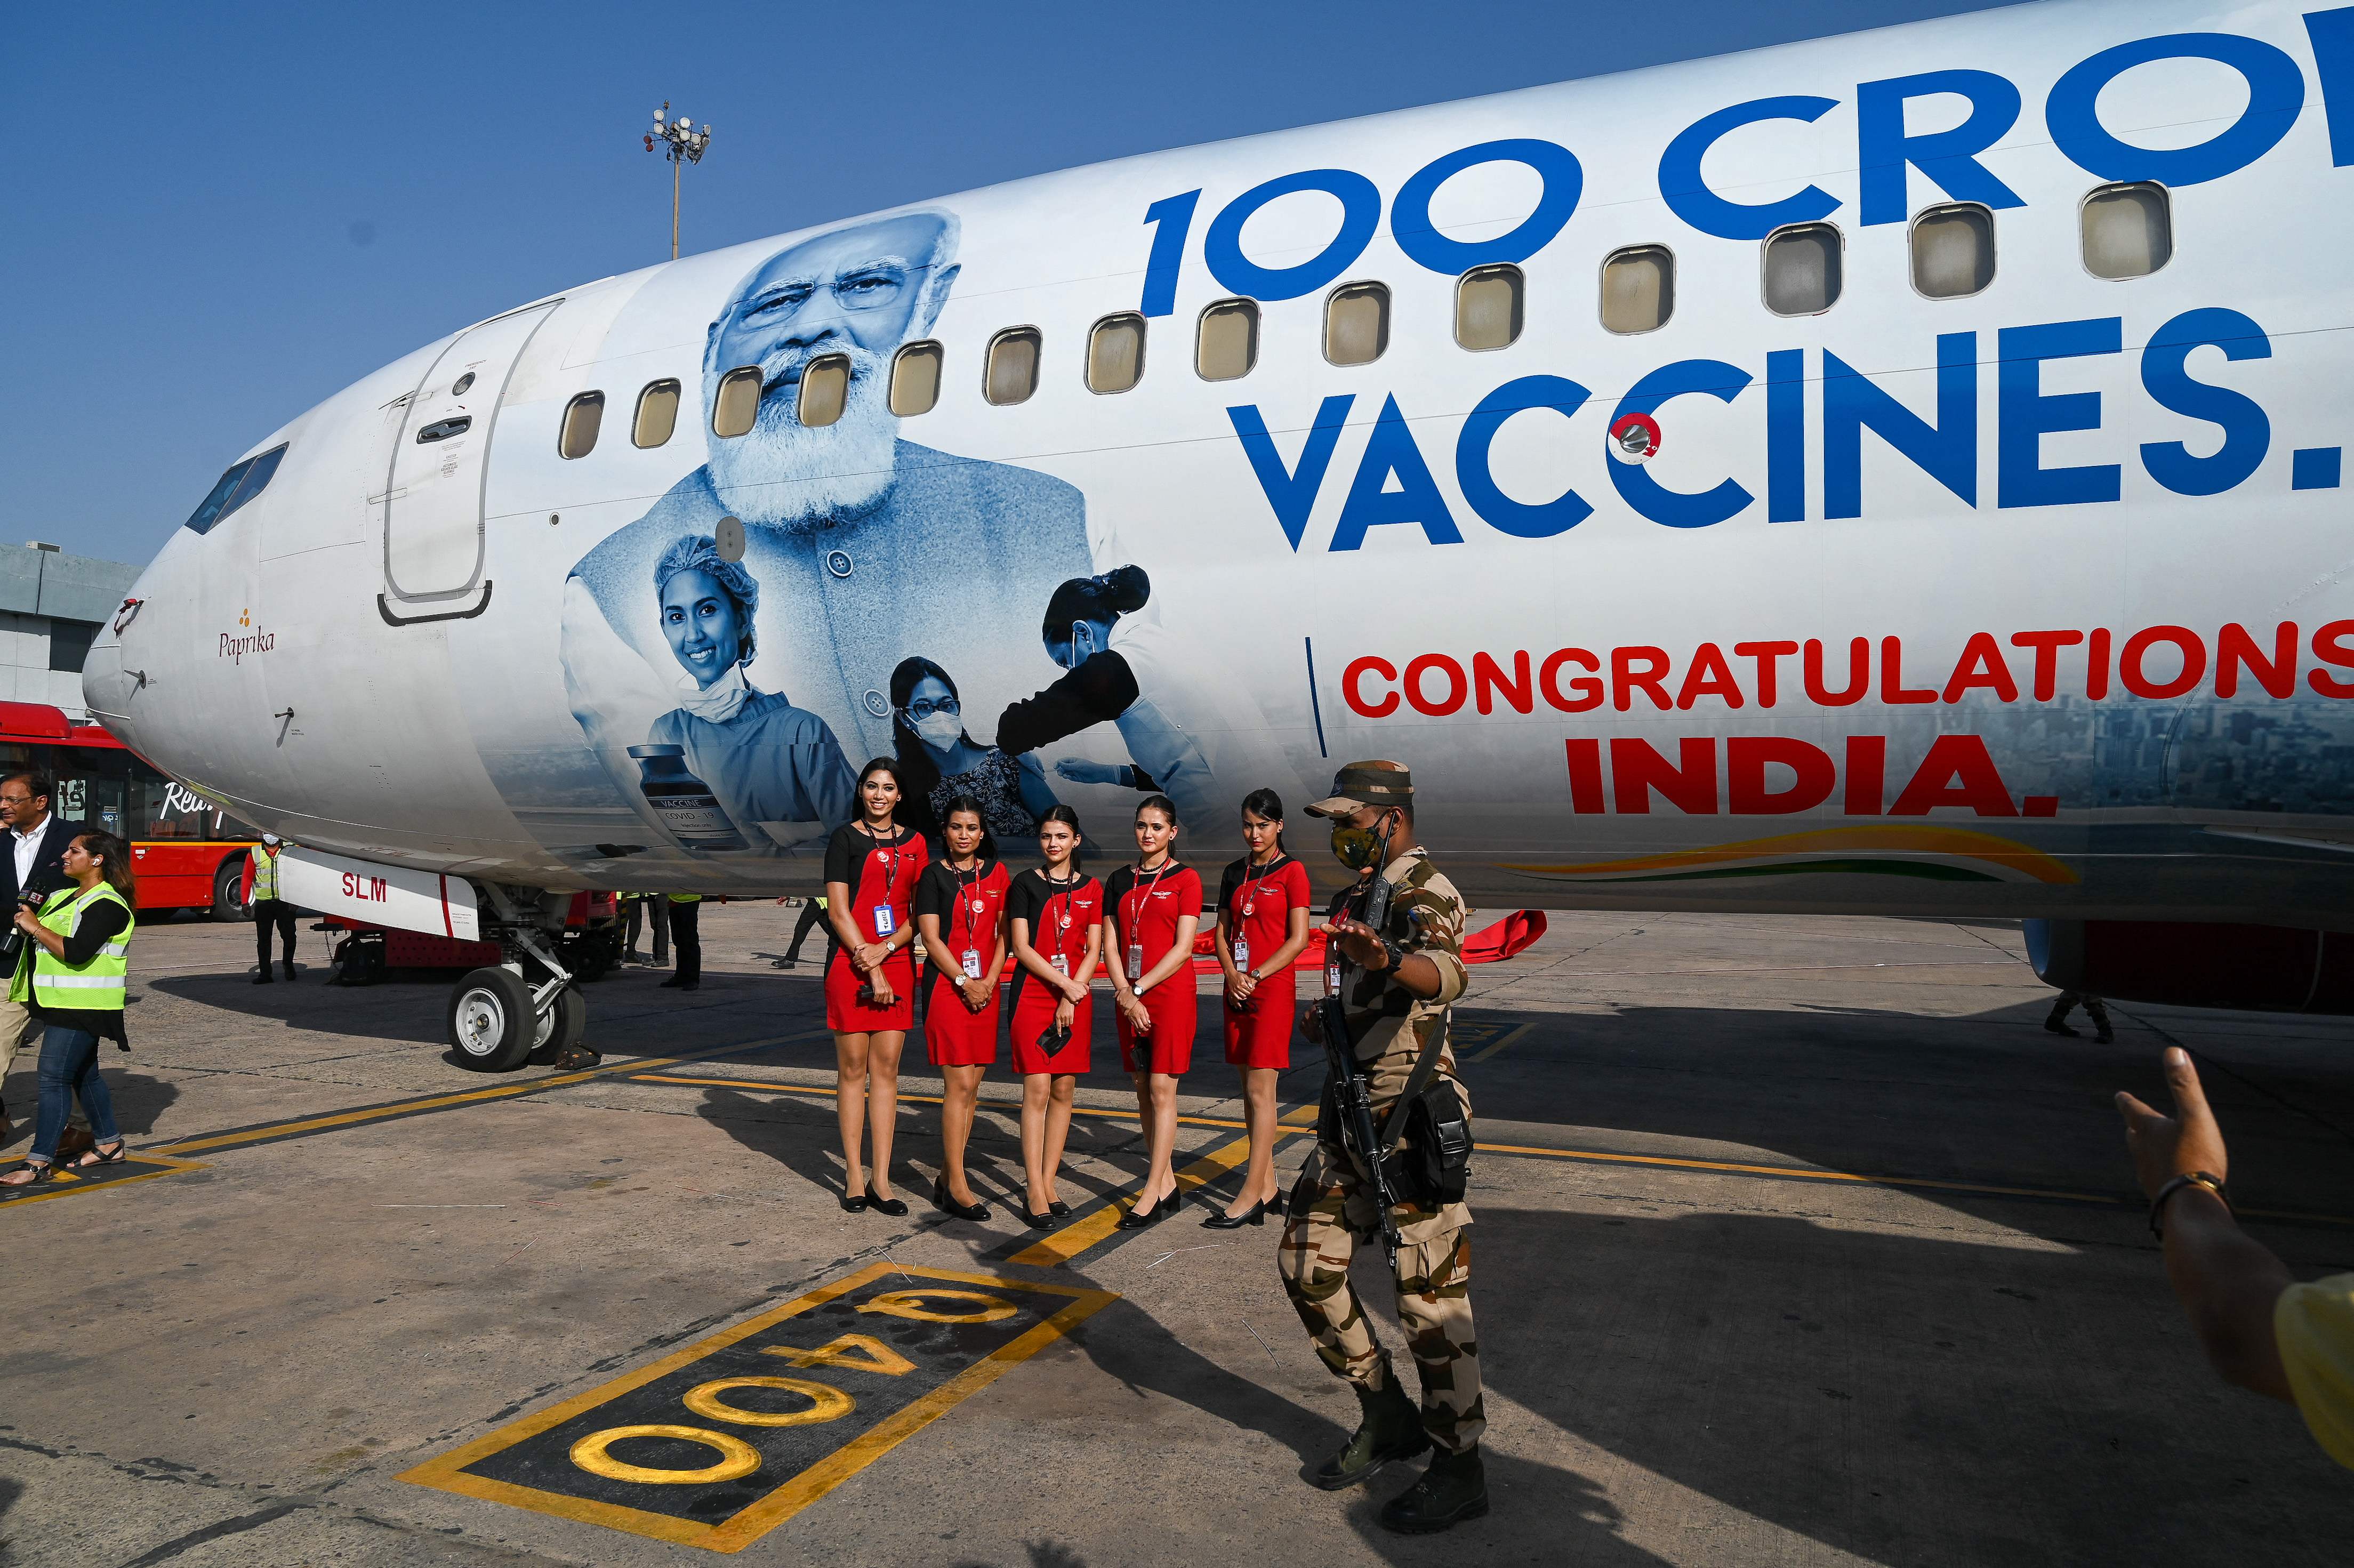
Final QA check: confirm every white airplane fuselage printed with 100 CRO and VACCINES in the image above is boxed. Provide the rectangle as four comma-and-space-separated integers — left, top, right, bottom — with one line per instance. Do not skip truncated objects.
85, 0, 2354, 930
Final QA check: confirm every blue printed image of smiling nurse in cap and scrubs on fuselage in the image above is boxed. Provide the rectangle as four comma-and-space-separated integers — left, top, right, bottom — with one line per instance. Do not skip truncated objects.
645, 534, 852, 848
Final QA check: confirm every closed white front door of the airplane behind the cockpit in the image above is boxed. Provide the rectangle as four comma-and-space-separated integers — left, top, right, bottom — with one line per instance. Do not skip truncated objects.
376, 301, 560, 626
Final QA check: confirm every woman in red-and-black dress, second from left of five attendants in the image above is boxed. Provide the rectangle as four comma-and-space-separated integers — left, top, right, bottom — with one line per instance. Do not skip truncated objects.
915, 796, 1008, 1219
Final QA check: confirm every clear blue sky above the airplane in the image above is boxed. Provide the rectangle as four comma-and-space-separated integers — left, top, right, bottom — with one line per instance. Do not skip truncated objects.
0, 0, 2015, 562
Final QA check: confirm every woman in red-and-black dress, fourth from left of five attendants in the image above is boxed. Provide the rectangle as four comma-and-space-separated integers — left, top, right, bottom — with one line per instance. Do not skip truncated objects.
1104, 796, 1201, 1232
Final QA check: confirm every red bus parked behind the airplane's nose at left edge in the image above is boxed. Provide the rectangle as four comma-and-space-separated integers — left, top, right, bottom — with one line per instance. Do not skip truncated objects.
0, 702, 261, 921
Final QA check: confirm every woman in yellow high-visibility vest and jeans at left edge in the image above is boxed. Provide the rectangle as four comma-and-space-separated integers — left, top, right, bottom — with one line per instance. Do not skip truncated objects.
0, 829, 139, 1187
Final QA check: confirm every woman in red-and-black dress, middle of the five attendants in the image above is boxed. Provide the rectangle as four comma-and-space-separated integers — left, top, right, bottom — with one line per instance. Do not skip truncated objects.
1005, 805, 1104, 1232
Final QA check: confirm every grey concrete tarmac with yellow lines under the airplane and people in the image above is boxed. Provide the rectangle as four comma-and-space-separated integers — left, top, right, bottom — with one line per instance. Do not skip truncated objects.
0, 904, 2354, 1568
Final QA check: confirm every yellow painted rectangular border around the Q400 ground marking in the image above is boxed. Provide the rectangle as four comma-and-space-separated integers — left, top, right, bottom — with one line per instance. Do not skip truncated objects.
398, 1262, 1121, 1551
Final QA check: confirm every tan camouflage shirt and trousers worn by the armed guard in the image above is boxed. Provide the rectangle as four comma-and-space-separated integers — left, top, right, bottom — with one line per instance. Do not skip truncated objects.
1276, 848, 1488, 1453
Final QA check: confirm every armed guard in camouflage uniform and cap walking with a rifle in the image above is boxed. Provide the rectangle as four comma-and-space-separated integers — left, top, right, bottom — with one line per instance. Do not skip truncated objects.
1278, 763, 1488, 1533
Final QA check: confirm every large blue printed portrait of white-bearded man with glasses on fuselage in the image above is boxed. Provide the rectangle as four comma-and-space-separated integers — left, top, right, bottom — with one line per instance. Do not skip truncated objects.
563, 210, 1092, 843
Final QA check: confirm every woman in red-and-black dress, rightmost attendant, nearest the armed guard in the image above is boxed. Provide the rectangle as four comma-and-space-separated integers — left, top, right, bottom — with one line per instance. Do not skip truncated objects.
1203, 789, 1311, 1232
